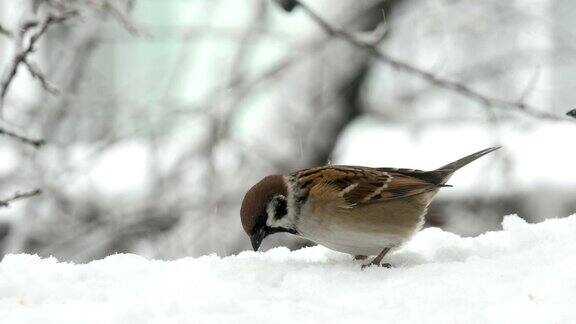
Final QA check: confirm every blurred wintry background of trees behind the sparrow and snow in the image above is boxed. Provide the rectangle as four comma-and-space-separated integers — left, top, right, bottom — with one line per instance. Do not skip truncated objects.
0, 0, 576, 262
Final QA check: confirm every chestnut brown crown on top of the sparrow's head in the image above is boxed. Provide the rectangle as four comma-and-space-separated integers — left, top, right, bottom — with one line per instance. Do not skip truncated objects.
240, 174, 288, 235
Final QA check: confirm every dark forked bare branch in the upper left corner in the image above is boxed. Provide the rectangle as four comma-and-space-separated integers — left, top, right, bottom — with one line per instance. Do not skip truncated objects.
0, 11, 78, 111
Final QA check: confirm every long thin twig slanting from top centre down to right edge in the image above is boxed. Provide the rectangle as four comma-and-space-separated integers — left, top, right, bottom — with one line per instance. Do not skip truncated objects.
294, 0, 570, 120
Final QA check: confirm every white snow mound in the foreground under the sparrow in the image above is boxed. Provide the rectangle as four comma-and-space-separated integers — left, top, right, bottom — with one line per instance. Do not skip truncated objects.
0, 215, 576, 324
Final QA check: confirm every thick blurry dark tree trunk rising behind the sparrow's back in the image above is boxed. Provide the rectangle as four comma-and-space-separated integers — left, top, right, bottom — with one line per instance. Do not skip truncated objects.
283, 0, 402, 171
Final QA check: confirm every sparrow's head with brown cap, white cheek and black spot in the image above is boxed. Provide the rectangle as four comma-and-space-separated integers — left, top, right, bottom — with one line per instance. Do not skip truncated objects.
240, 175, 295, 251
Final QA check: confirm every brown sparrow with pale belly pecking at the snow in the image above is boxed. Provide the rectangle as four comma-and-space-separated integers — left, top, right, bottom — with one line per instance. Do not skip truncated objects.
240, 147, 500, 268
